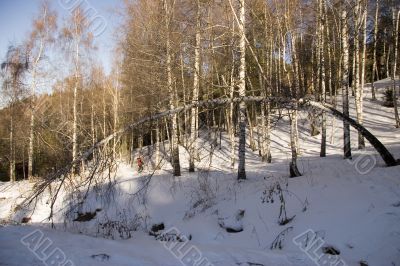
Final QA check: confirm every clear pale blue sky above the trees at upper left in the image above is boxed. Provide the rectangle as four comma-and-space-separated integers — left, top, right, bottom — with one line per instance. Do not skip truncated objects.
0, 0, 122, 72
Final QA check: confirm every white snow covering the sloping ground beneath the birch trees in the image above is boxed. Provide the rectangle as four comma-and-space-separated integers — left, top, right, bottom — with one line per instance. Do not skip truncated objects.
0, 80, 400, 266
